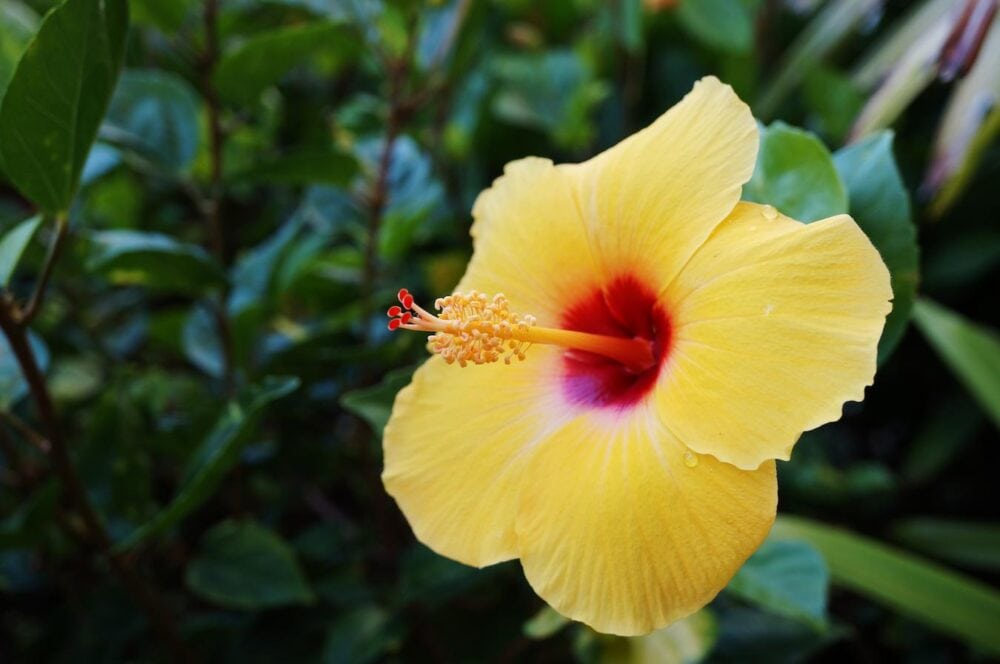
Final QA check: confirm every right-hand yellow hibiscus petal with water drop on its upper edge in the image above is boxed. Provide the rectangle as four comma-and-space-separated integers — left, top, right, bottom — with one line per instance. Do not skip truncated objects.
656, 203, 892, 468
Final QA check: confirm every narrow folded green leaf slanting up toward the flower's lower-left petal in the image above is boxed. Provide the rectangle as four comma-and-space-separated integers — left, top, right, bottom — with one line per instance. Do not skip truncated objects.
116, 377, 299, 551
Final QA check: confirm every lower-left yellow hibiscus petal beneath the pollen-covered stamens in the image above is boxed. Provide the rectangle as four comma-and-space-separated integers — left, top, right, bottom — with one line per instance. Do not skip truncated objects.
382, 348, 568, 567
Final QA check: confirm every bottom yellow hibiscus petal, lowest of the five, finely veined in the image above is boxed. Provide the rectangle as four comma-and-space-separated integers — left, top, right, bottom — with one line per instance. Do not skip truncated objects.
517, 407, 777, 636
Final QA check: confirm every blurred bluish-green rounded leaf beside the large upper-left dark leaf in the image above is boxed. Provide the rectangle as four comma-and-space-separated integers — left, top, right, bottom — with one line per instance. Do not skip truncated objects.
101, 69, 201, 172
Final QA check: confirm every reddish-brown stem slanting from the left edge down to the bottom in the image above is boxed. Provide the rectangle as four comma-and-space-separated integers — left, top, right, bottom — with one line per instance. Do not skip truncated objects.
0, 293, 191, 661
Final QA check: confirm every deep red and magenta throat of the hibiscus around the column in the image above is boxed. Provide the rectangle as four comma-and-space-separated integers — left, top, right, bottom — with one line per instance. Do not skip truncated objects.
560, 274, 671, 409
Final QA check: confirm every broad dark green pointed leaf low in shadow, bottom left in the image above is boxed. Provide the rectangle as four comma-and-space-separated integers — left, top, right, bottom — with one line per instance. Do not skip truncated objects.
184, 521, 314, 611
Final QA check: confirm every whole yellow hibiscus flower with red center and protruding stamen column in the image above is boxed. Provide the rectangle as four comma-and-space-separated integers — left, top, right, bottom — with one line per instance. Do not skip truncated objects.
383, 78, 891, 635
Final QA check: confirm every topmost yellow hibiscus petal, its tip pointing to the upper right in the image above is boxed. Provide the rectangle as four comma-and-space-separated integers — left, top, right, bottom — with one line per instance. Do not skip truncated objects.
568, 77, 758, 286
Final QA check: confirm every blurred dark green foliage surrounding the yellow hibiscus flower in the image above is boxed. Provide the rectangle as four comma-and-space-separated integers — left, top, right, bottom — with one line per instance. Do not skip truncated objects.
0, 0, 1000, 662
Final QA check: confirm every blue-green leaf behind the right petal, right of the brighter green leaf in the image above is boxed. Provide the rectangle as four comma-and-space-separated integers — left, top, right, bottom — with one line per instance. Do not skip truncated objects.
833, 131, 920, 361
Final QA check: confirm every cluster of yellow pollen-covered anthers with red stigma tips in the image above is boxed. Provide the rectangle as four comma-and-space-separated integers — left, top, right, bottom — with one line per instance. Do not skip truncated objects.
387, 288, 535, 367
